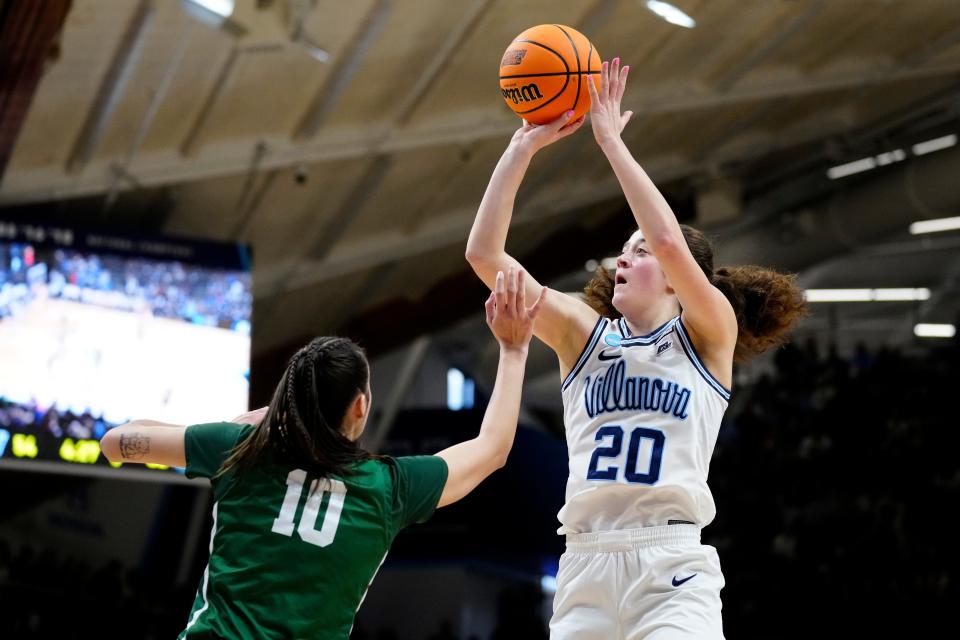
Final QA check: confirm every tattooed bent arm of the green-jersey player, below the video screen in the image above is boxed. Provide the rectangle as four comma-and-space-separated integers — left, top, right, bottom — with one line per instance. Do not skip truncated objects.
100, 420, 187, 467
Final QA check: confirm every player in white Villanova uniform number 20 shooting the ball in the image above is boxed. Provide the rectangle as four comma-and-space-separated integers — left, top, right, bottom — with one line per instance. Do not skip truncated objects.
467, 59, 805, 640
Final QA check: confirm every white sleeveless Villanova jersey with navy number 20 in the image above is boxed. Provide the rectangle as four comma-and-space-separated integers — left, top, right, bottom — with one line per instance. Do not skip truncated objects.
558, 317, 730, 534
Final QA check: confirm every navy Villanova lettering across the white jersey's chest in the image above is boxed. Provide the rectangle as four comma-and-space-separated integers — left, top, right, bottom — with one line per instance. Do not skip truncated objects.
583, 360, 690, 420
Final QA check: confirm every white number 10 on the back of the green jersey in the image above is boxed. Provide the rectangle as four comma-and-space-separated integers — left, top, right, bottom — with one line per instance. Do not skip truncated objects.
271, 469, 347, 547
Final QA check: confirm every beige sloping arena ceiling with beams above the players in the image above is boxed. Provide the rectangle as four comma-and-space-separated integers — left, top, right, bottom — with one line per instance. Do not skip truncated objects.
0, 0, 960, 408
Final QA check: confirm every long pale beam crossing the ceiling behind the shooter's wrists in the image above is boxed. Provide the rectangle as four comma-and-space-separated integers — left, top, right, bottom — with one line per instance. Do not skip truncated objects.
7, 57, 960, 204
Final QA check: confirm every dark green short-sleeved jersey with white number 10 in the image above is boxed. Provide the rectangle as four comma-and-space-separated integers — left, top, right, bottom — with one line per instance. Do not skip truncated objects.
179, 423, 447, 640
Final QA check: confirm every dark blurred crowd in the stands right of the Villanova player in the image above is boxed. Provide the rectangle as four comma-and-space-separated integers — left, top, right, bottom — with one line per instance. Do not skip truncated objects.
704, 343, 960, 638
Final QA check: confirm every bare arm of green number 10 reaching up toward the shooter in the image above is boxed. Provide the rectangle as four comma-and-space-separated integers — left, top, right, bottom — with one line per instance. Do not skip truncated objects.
437, 269, 547, 507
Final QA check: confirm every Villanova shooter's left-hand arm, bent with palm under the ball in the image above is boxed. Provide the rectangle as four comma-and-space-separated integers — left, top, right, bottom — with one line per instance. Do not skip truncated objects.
466, 115, 598, 376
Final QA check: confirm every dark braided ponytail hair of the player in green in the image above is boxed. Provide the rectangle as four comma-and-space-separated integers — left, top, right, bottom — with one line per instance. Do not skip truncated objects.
217, 337, 372, 476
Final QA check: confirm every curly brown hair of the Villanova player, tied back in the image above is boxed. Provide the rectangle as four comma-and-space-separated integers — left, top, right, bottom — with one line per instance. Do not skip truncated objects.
583, 224, 807, 362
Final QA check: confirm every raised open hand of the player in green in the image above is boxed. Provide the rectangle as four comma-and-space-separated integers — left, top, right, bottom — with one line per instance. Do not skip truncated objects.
484, 269, 547, 351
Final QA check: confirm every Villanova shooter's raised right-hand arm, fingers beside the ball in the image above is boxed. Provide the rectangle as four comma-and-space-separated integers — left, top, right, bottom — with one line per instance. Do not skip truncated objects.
587, 58, 737, 363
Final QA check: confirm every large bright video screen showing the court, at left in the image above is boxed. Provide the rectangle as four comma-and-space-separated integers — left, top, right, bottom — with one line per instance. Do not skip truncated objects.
0, 221, 253, 476
